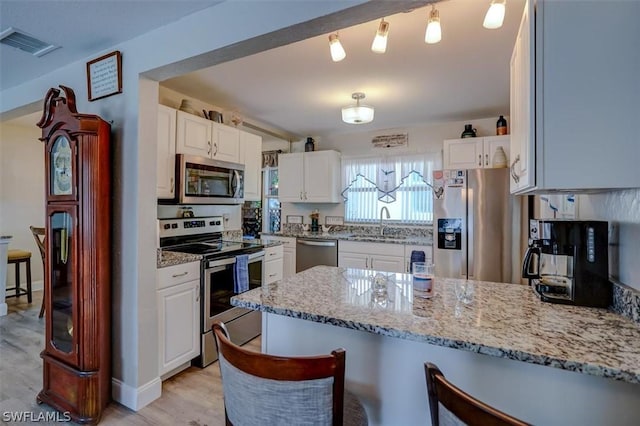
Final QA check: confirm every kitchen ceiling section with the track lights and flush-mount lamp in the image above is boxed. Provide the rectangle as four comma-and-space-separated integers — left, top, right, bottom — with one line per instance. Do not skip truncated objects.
162, 0, 524, 137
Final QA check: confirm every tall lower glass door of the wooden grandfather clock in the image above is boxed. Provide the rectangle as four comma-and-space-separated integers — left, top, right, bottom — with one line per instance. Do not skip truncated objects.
48, 206, 78, 354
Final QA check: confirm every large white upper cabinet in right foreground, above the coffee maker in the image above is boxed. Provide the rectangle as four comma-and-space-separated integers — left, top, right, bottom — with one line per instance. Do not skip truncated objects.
510, 0, 640, 193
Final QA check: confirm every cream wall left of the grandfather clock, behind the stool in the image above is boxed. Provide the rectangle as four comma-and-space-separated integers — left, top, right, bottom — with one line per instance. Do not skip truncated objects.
0, 122, 45, 289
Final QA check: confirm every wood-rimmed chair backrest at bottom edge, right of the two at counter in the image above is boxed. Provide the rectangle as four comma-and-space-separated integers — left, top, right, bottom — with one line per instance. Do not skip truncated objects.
424, 362, 528, 426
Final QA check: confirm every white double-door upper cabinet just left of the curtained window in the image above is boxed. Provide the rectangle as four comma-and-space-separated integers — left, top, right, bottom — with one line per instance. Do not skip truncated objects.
278, 151, 341, 203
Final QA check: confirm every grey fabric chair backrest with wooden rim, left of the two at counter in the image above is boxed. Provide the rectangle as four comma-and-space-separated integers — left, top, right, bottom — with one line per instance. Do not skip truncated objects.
212, 322, 345, 426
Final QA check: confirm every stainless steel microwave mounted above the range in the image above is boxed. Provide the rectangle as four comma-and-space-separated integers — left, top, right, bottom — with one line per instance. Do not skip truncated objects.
174, 154, 244, 204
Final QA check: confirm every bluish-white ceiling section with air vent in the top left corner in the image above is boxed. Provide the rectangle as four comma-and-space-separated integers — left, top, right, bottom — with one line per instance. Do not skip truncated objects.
0, 0, 221, 90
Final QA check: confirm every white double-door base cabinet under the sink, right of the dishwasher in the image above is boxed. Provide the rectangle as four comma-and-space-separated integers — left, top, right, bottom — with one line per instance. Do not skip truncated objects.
338, 241, 405, 272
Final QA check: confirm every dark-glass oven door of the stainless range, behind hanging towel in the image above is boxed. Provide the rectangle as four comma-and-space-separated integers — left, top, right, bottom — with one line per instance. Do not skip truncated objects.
202, 251, 264, 333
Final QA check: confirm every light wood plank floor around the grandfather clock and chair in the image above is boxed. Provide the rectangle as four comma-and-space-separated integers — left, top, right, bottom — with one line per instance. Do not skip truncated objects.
0, 291, 260, 426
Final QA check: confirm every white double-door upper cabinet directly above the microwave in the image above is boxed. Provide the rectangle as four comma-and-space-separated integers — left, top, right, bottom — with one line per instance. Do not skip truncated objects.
176, 111, 240, 163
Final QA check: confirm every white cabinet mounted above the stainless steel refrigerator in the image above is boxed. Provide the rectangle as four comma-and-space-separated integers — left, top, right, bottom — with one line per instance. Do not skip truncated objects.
443, 135, 509, 169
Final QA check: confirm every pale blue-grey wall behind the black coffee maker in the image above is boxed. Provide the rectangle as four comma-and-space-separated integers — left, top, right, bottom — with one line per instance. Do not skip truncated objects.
578, 189, 640, 291
